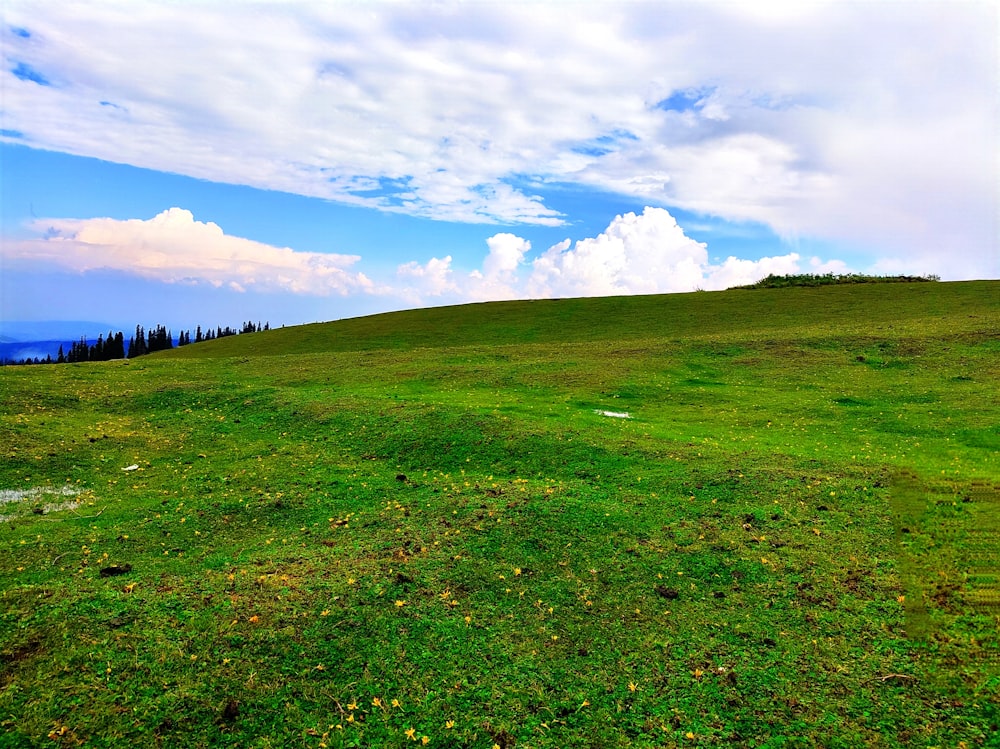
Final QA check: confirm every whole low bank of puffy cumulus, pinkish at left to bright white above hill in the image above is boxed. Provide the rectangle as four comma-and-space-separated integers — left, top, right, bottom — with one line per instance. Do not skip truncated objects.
0, 206, 852, 307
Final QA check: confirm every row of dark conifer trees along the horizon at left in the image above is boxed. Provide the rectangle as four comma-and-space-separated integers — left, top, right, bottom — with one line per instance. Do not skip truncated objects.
3, 321, 271, 364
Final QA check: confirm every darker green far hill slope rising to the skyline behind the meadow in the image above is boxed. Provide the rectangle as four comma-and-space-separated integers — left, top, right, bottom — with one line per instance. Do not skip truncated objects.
160, 281, 1000, 357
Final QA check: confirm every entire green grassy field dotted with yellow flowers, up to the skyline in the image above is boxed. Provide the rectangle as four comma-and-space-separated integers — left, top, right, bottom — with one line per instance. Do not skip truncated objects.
0, 282, 1000, 749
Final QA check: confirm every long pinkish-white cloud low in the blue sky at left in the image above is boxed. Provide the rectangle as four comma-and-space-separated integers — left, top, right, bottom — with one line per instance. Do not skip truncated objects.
3, 208, 380, 296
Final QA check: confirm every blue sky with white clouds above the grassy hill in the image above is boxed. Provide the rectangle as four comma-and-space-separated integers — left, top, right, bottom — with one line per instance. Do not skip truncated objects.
0, 0, 1000, 335
